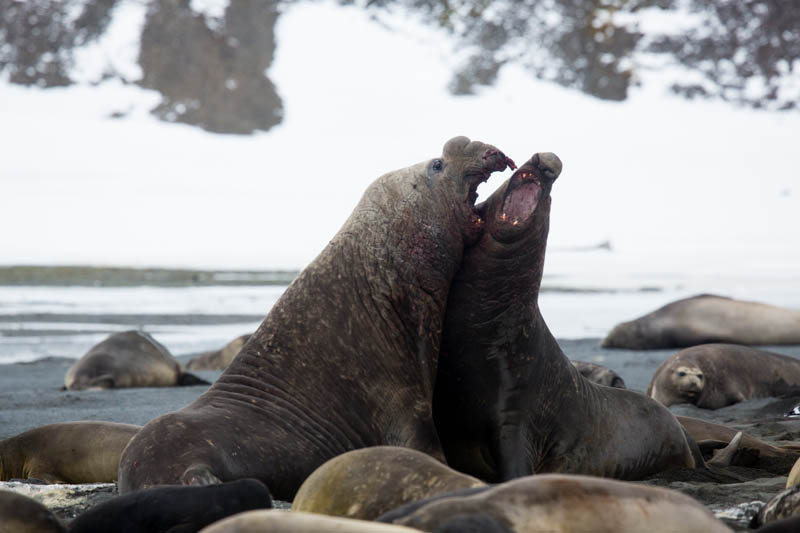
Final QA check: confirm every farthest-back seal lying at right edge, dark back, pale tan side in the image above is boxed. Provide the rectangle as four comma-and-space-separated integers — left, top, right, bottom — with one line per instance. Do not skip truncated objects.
602, 294, 800, 350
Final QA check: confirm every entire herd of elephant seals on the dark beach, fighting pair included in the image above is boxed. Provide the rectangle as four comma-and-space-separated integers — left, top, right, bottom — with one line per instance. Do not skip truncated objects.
0, 137, 800, 533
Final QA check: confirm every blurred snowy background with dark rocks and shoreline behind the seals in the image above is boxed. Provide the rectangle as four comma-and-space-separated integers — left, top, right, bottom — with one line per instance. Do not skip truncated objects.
0, 0, 800, 361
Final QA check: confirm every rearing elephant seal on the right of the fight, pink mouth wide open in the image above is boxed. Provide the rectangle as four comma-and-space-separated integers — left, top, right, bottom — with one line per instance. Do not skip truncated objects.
434, 154, 696, 482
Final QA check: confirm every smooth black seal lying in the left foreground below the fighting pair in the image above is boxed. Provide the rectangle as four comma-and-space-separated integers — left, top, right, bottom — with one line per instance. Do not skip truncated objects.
69, 479, 272, 533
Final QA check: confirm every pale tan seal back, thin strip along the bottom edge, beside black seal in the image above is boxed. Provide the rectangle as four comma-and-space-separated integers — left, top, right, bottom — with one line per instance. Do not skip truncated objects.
200, 509, 420, 533
